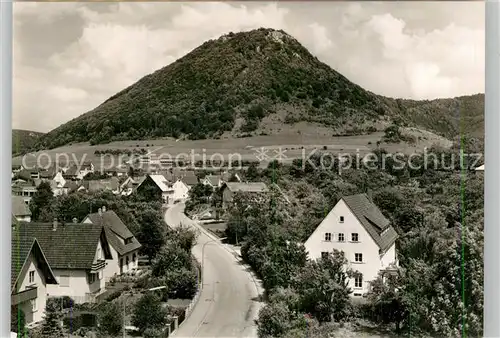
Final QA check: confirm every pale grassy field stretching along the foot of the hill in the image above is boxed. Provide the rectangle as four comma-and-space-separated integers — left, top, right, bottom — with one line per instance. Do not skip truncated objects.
12, 131, 452, 167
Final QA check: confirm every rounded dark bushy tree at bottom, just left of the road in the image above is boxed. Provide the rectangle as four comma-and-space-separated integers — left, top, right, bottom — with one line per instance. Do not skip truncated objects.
132, 292, 167, 333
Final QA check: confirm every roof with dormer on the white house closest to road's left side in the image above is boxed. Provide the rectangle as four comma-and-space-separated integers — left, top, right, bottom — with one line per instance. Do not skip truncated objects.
87, 210, 141, 256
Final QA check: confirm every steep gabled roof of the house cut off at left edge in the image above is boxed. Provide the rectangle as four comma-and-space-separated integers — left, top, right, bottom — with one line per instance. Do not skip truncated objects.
10, 228, 57, 292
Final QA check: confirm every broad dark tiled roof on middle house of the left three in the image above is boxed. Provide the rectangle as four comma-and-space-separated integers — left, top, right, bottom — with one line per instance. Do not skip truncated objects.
19, 222, 111, 269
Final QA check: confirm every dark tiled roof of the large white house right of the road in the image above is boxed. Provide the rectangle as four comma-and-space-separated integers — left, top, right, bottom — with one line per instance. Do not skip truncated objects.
342, 194, 398, 252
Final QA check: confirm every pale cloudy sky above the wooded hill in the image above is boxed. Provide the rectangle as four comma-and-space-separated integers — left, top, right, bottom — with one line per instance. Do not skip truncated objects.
12, 1, 485, 132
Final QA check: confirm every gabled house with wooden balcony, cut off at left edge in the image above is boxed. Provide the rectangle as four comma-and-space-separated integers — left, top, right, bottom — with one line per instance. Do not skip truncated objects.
10, 228, 57, 327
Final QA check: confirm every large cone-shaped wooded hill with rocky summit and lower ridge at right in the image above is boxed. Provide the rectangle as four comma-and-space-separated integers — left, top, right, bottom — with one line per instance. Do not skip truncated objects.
32, 28, 484, 150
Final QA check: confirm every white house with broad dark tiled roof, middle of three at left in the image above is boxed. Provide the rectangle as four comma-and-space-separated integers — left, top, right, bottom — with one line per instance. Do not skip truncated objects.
19, 220, 112, 304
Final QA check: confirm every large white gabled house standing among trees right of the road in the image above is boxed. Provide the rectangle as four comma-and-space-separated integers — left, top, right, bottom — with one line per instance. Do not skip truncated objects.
304, 194, 398, 297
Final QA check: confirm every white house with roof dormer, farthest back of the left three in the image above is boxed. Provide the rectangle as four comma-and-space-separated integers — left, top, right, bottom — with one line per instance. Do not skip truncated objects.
82, 206, 141, 282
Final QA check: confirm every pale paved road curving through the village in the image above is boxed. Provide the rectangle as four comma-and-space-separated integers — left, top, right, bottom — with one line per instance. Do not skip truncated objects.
165, 203, 262, 338
